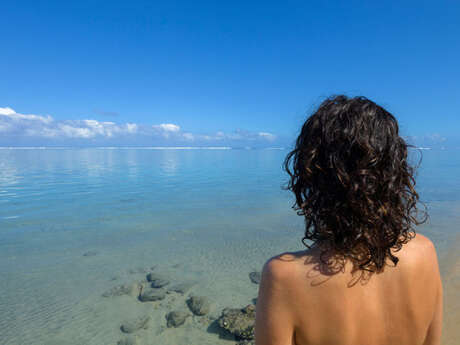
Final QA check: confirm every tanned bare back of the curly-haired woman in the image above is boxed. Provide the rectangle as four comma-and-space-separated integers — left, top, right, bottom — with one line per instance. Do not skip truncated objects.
256, 235, 442, 345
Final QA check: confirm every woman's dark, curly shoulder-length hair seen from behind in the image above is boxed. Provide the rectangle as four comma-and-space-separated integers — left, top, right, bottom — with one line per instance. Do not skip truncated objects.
284, 95, 428, 272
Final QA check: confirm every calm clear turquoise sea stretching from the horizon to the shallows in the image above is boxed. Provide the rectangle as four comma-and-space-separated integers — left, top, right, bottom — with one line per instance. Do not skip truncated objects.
0, 148, 460, 345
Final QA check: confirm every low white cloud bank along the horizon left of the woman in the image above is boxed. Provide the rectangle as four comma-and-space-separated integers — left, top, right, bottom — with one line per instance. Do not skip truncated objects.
0, 107, 279, 147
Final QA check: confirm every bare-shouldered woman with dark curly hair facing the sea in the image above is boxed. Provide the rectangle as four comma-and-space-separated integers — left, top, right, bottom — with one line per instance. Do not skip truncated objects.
255, 96, 442, 345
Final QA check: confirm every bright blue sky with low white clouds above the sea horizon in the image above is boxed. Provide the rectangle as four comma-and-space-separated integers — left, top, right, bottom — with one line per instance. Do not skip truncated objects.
0, 1, 460, 146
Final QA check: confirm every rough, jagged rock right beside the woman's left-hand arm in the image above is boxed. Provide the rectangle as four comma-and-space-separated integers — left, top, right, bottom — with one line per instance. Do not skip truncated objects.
218, 304, 256, 340
